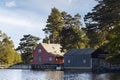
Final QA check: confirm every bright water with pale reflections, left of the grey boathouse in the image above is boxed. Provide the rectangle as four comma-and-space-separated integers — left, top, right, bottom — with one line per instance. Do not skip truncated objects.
0, 69, 64, 80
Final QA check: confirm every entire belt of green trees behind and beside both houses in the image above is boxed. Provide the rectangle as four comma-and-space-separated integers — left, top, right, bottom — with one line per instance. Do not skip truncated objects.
0, 0, 120, 64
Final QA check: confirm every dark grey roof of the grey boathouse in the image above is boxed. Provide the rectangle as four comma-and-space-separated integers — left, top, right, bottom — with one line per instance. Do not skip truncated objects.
65, 48, 95, 55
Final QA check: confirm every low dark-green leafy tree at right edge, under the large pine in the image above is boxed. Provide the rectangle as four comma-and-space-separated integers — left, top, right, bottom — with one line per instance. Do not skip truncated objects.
105, 25, 120, 64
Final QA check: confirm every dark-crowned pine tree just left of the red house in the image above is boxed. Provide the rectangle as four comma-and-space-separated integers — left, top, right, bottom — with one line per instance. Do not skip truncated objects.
16, 34, 39, 64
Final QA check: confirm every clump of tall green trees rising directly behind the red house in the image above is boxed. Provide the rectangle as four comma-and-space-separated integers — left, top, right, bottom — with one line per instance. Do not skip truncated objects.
43, 8, 88, 51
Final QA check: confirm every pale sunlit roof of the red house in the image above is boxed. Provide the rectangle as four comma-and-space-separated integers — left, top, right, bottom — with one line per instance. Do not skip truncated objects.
41, 43, 64, 56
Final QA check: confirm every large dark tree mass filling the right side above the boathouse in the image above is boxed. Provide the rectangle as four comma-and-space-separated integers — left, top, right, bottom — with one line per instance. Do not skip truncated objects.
85, 0, 120, 64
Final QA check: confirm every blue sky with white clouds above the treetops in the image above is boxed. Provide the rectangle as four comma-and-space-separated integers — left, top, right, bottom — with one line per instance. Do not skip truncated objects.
0, 0, 97, 47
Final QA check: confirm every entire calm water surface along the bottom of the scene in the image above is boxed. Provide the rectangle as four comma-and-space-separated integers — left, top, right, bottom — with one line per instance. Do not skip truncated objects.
0, 69, 120, 80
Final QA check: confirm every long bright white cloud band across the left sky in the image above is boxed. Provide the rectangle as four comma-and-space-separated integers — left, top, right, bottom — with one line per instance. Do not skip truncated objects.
0, 9, 45, 29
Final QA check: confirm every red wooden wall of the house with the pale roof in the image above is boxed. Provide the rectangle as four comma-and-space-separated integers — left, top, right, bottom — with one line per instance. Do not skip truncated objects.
32, 44, 59, 64
